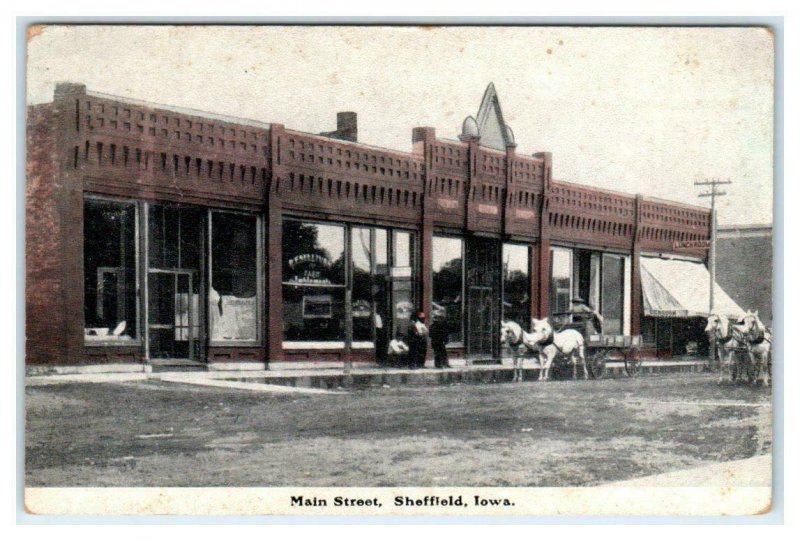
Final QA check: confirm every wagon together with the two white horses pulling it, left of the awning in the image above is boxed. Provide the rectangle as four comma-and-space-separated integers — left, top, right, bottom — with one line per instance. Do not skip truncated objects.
501, 312, 642, 381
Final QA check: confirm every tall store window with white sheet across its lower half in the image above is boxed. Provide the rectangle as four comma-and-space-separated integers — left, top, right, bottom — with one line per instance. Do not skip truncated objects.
208, 211, 260, 342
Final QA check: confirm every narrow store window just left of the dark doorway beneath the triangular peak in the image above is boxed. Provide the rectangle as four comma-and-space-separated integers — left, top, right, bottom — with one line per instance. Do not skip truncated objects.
432, 236, 464, 343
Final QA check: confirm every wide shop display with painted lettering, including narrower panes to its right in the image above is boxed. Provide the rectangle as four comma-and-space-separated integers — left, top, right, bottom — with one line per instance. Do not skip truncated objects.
283, 218, 415, 348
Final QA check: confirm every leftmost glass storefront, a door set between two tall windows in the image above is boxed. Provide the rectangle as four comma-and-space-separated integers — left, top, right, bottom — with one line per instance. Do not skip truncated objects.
83, 195, 263, 370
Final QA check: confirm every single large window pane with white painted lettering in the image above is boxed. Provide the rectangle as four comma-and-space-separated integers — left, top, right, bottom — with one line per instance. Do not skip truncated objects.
283, 220, 346, 345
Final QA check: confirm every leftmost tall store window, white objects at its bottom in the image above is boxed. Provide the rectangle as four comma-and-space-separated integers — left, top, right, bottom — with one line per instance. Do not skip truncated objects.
83, 199, 137, 344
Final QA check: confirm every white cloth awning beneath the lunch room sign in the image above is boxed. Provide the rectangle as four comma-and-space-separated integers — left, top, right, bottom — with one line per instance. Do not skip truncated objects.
639, 257, 744, 318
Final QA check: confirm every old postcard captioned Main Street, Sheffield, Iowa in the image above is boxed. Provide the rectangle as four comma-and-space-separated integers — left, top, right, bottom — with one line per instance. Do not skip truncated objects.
25, 24, 781, 517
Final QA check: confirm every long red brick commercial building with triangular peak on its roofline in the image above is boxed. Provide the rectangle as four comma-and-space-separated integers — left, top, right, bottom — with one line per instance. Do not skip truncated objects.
26, 84, 738, 371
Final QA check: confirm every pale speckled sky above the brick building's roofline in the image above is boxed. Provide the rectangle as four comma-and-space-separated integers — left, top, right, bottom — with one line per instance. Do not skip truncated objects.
27, 26, 774, 225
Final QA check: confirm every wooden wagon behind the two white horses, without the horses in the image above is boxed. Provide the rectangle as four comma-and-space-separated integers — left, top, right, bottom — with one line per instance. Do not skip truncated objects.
553, 312, 642, 379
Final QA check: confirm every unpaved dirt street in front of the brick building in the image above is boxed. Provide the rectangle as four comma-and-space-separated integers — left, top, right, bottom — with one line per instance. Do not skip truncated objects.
26, 374, 772, 486
